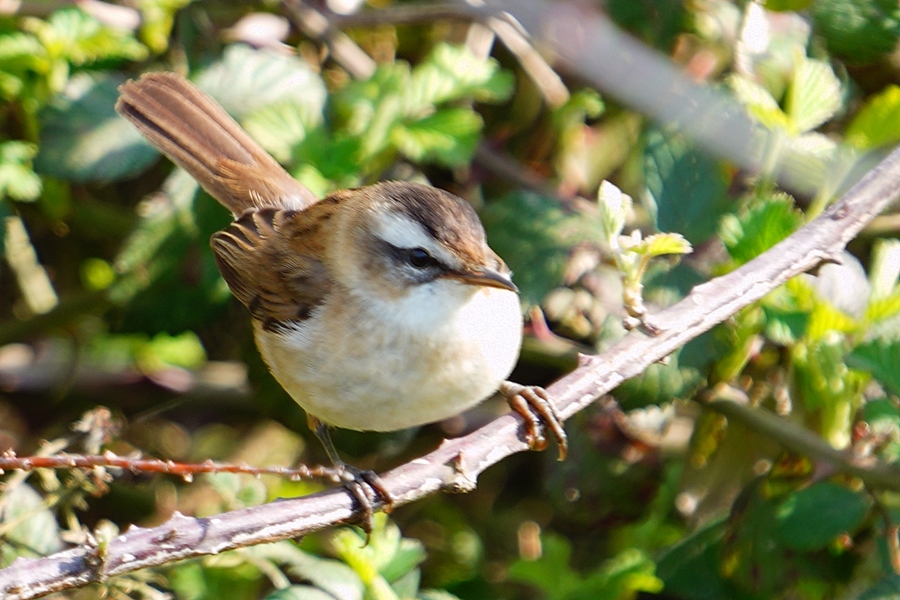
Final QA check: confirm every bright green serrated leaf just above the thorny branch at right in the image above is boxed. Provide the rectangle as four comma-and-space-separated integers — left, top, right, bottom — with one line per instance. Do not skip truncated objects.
719, 195, 802, 265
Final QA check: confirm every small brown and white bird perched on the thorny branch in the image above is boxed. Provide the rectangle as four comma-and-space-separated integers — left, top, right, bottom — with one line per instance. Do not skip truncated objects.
116, 71, 568, 524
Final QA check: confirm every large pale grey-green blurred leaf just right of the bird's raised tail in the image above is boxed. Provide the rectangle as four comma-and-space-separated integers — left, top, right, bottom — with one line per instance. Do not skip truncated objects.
196, 44, 326, 119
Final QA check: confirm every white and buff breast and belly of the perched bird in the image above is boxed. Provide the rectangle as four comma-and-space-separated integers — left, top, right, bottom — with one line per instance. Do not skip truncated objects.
256, 279, 522, 431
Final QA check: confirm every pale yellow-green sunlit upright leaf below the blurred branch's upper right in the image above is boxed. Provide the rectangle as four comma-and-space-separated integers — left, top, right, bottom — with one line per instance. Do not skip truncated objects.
785, 57, 841, 133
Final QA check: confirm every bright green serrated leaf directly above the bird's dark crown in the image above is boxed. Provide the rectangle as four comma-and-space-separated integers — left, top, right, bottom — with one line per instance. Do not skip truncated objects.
393, 108, 482, 167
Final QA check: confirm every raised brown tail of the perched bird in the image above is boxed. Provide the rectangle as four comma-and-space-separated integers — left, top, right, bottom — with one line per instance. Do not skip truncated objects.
116, 72, 316, 216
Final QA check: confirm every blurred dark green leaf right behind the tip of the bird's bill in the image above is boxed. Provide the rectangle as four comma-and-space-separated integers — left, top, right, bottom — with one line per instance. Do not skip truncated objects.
481, 192, 603, 305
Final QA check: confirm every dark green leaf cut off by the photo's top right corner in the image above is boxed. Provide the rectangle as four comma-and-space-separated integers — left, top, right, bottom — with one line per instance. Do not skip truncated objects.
810, 0, 900, 63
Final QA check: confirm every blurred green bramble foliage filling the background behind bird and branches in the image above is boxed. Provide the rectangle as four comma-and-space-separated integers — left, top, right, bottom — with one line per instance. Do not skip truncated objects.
0, 0, 900, 599
